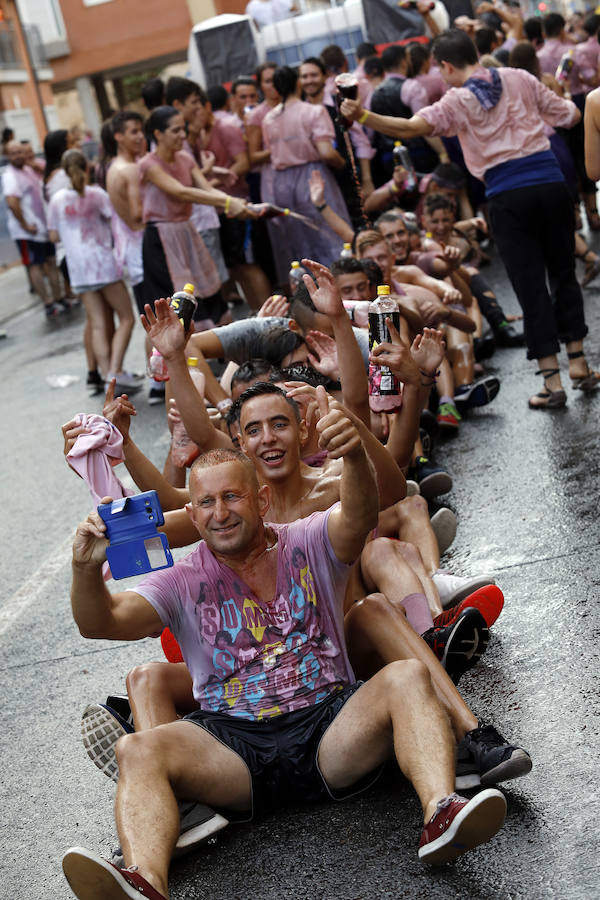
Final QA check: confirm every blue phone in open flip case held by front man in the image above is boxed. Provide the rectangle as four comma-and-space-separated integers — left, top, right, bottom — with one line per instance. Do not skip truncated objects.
98, 491, 173, 579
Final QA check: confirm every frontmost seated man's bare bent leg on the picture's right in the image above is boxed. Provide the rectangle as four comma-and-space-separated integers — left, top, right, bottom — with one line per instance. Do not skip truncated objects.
318, 659, 455, 822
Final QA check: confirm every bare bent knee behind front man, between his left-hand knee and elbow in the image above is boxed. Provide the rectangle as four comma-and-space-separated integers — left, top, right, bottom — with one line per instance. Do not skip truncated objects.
127, 662, 198, 731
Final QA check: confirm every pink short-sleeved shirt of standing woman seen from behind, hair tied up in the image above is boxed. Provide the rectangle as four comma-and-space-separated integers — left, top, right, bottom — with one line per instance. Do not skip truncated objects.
263, 100, 335, 170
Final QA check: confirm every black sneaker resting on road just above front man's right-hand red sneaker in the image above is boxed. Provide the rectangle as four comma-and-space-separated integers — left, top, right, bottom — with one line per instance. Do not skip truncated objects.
456, 723, 532, 790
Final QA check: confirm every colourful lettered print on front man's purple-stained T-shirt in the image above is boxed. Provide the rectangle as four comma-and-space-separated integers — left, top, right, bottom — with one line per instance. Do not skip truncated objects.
196, 546, 345, 719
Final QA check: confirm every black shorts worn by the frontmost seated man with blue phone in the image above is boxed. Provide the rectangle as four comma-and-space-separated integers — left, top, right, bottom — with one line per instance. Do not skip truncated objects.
185, 682, 383, 822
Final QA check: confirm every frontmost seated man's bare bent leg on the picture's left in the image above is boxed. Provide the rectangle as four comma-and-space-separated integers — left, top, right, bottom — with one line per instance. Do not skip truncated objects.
115, 722, 251, 897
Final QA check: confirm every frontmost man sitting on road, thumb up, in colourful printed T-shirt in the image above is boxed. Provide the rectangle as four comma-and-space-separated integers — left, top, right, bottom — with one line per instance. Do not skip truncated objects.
63, 410, 506, 900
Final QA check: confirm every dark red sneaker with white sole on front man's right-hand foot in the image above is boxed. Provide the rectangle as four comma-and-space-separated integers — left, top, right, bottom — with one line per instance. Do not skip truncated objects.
419, 788, 506, 866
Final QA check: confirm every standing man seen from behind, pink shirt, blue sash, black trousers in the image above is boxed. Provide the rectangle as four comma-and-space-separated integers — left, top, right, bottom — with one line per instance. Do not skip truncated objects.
342, 29, 600, 409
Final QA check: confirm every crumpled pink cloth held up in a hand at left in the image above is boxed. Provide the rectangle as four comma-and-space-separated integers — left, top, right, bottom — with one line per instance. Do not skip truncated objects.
67, 413, 135, 504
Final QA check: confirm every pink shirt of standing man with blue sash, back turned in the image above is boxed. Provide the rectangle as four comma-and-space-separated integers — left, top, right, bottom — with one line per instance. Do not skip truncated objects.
419, 66, 578, 178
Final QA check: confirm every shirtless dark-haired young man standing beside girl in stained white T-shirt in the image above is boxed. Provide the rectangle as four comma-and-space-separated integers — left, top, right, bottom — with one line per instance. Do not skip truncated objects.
106, 109, 150, 314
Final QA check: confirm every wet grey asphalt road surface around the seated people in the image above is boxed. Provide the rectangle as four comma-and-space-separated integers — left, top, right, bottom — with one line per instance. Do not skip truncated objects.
0, 255, 600, 900
